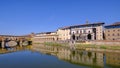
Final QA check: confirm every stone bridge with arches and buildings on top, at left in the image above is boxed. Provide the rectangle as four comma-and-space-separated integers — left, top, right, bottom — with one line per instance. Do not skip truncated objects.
0, 35, 32, 48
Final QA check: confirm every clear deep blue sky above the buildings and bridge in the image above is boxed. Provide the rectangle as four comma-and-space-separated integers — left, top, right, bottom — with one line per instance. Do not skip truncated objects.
0, 0, 120, 35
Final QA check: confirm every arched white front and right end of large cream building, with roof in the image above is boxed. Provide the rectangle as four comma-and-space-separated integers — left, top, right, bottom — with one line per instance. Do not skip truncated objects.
71, 23, 104, 40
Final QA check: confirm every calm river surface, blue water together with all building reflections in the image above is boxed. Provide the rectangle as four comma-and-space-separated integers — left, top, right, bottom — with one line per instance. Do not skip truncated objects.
0, 46, 120, 68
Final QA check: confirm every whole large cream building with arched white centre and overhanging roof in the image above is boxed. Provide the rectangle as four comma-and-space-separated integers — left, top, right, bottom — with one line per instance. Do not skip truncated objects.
57, 23, 104, 41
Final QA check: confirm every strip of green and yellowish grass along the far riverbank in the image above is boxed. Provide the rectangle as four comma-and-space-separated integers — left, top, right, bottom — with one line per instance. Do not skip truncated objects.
33, 42, 120, 50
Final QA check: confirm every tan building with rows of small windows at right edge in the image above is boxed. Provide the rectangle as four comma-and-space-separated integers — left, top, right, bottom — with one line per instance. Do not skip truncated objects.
105, 23, 120, 40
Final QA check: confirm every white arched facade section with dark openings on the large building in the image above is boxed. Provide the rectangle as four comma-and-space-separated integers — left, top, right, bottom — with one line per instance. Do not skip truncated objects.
71, 28, 96, 40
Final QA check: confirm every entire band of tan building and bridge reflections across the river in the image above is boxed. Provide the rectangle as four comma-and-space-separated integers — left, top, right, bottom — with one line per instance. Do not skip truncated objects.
0, 45, 120, 68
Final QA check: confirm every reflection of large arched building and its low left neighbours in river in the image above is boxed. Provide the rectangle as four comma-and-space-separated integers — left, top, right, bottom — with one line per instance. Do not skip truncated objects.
33, 46, 104, 67
